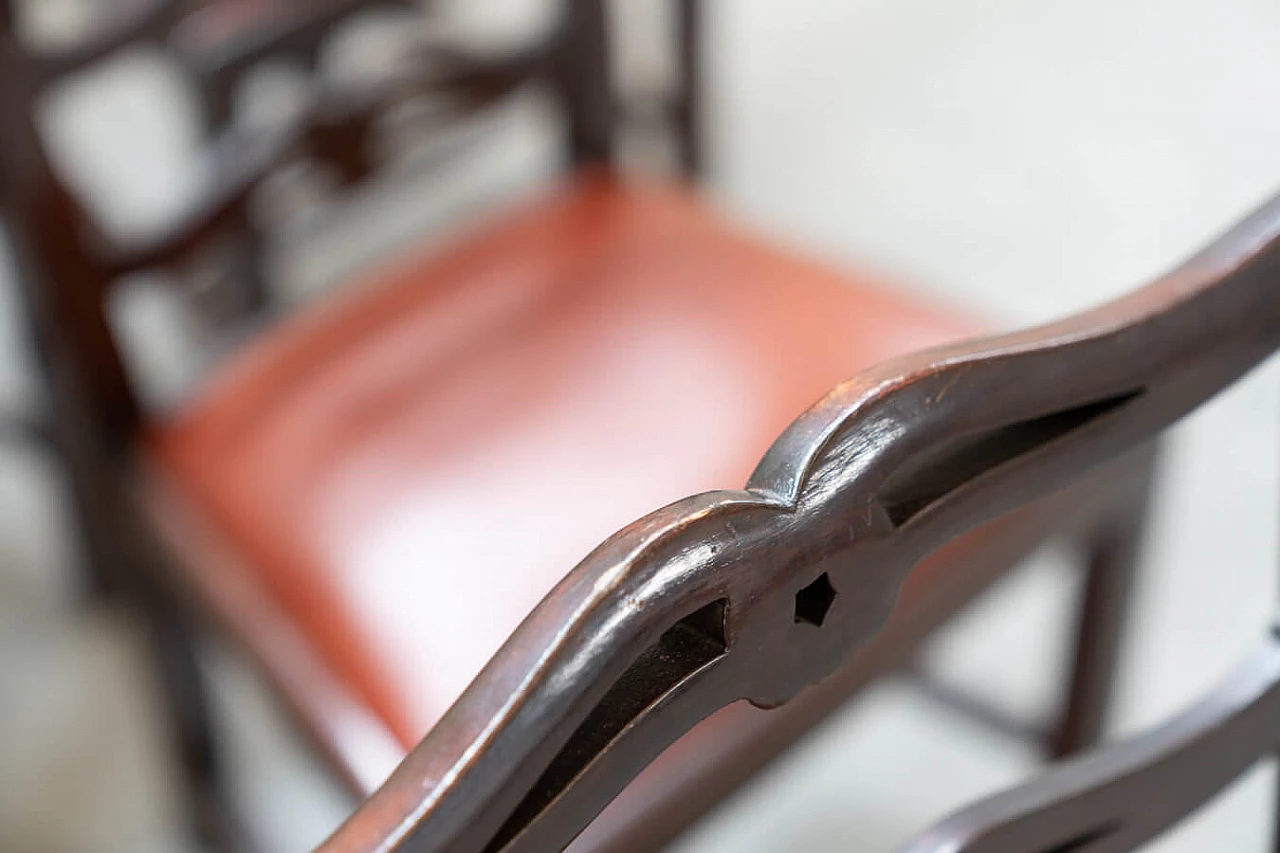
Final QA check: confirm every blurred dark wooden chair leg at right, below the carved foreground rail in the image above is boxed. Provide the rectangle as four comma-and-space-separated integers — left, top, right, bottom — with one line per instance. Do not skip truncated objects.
1046, 450, 1156, 760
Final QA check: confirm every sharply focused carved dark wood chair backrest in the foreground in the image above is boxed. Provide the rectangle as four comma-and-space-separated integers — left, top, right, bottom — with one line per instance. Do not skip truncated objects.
302, 180, 1280, 853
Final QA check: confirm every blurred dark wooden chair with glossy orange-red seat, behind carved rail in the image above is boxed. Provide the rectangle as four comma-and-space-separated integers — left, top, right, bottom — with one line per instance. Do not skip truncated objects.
0, 0, 1153, 850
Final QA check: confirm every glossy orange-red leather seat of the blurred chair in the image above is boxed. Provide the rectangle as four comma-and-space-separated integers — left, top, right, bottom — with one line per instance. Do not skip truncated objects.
143, 174, 973, 748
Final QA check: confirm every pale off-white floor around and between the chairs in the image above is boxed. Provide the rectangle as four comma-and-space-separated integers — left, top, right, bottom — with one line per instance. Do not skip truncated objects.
0, 0, 1280, 853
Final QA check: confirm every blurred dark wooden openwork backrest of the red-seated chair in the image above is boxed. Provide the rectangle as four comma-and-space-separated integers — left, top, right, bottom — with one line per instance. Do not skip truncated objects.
0, 0, 700, 446
